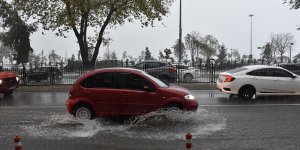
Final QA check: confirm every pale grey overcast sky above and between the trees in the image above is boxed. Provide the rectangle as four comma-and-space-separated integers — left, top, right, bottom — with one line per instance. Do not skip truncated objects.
31, 0, 300, 61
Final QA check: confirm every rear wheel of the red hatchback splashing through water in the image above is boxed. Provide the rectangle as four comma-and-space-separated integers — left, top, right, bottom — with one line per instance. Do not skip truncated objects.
74, 105, 95, 120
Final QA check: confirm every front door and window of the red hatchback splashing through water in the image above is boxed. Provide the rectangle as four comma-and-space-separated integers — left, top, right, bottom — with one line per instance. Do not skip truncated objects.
120, 73, 159, 114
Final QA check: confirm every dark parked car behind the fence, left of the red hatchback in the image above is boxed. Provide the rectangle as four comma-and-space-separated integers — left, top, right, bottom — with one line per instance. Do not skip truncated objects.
26, 66, 63, 82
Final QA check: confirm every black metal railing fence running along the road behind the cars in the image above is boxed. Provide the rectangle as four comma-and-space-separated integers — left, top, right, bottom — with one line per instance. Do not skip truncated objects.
5, 64, 300, 86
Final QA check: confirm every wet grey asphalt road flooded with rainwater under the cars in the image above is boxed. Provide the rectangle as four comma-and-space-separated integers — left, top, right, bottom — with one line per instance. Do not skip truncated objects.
0, 90, 300, 150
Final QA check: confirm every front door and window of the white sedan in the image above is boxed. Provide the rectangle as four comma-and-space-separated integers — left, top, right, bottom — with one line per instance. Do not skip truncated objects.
270, 68, 300, 94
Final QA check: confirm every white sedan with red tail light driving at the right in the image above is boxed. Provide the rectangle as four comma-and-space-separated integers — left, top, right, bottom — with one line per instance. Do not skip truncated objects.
217, 65, 300, 99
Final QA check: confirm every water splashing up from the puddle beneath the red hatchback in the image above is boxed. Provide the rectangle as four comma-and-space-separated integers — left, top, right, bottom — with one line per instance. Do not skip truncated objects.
20, 109, 226, 140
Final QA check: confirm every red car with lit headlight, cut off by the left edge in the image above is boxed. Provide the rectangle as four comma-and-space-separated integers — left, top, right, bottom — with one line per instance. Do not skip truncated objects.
0, 66, 20, 95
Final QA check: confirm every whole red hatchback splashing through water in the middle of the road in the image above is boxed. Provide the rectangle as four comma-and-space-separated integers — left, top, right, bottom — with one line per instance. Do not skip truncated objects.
66, 68, 198, 119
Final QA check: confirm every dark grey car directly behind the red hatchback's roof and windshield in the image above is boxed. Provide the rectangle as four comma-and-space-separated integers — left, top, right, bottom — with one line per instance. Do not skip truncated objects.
133, 60, 176, 83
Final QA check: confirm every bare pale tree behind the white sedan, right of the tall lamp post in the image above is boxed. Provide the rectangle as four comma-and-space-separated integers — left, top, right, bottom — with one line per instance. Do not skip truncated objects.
271, 33, 295, 63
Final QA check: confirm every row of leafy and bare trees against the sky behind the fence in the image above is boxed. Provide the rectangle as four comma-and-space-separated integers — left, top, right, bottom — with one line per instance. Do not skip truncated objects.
0, 0, 300, 68
